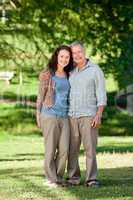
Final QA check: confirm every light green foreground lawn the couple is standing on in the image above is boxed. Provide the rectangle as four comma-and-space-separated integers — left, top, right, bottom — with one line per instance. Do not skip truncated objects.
0, 134, 133, 200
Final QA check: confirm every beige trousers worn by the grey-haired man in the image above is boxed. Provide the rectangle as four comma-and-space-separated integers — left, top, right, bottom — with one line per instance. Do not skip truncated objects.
68, 117, 98, 183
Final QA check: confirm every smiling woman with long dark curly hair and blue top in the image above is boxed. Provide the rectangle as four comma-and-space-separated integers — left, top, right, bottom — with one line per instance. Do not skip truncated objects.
36, 45, 73, 187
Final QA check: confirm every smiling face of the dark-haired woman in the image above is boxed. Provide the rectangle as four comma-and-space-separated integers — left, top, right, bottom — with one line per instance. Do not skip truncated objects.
57, 49, 70, 68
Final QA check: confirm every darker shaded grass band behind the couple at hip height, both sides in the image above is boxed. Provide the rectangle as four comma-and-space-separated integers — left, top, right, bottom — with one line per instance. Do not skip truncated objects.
0, 103, 133, 136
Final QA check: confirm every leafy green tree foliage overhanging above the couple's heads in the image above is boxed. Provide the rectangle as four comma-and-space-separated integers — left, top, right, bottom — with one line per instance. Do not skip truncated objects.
0, 0, 133, 88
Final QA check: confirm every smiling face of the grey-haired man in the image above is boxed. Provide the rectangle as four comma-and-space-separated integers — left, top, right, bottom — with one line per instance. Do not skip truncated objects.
71, 45, 85, 64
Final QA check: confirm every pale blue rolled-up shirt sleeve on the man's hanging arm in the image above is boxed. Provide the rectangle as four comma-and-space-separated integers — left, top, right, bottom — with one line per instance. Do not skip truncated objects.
95, 66, 107, 107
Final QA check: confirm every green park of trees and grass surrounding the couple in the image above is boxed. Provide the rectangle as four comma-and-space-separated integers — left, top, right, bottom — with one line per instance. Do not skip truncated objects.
0, 0, 133, 200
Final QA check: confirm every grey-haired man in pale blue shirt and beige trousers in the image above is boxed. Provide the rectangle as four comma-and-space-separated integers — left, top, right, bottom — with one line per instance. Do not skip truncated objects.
68, 42, 107, 186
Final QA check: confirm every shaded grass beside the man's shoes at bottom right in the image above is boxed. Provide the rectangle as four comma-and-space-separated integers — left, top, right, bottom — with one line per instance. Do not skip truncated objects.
66, 167, 133, 200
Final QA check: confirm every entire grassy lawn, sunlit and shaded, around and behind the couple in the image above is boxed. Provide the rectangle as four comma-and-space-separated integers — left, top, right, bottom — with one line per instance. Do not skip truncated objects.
0, 75, 133, 200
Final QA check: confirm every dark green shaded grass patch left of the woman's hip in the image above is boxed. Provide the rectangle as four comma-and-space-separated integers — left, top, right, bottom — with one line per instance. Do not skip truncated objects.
0, 105, 41, 135
